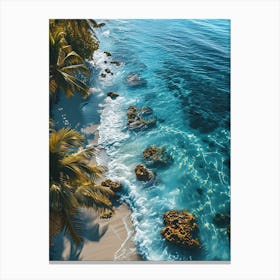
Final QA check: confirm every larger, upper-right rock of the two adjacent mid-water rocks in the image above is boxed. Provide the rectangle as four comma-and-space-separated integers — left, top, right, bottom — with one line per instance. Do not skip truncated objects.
143, 145, 171, 166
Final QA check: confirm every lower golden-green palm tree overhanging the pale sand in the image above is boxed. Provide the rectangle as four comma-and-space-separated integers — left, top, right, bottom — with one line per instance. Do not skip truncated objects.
49, 128, 114, 244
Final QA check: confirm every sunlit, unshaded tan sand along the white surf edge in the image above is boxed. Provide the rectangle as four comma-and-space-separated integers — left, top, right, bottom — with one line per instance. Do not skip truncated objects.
80, 123, 143, 261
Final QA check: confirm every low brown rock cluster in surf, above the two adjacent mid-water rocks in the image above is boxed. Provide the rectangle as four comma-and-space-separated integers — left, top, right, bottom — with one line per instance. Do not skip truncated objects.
126, 106, 156, 130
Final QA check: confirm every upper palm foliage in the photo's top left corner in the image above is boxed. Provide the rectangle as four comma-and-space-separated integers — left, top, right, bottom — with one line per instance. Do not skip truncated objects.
49, 20, 99, 101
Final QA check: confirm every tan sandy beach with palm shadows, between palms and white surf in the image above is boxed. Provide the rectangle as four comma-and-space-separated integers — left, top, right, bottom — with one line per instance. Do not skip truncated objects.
49, 124, 142, 261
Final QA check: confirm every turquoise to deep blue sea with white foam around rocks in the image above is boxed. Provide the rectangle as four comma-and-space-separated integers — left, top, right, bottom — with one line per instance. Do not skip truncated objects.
52, 20, 230, 260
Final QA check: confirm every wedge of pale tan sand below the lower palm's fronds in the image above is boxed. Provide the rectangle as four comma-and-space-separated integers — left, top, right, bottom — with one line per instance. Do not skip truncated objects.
79, 204, 142, 261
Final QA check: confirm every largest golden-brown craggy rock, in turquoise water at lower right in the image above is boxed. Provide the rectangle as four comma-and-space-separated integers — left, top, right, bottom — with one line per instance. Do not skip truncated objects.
161, 210, 201, 249
